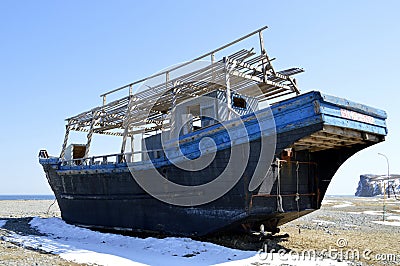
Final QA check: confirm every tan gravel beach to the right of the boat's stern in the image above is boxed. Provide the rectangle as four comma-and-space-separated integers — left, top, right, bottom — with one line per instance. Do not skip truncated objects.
280, 197, 400, 265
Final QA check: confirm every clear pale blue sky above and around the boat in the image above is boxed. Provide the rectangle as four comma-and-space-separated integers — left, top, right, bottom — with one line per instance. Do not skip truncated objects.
0, 0, 400, 194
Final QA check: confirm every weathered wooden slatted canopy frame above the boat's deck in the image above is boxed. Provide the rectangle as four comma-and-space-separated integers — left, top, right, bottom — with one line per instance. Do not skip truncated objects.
60, 26, 304, 159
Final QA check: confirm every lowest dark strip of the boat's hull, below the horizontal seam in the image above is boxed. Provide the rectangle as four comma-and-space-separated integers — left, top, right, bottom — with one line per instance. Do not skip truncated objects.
55, 194, 314, 236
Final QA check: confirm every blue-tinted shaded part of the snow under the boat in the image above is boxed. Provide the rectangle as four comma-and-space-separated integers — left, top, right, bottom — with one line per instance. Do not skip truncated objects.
30, 218, 256, 265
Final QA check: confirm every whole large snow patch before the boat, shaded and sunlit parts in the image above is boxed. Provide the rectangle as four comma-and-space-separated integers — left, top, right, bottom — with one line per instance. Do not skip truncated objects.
0, 217, 348, 266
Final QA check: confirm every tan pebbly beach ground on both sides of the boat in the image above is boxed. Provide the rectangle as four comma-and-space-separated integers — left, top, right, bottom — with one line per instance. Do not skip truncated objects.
0, 197, 400, 265
